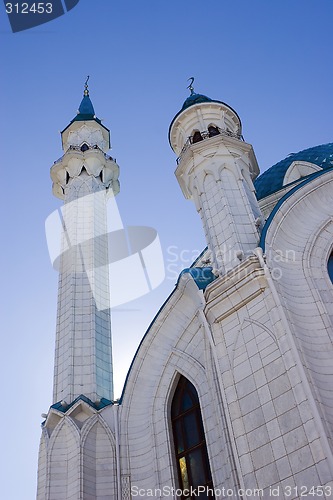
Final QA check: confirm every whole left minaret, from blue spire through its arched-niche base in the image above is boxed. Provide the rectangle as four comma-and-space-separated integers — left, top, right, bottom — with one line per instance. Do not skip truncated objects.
37, 79, 119, 500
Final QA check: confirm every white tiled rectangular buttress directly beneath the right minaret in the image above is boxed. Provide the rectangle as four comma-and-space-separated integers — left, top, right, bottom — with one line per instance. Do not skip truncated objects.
207, 263, 333, 498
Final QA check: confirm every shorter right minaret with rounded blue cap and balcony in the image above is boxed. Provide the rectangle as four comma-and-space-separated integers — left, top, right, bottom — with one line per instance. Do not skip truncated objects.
169, 79, 262, 273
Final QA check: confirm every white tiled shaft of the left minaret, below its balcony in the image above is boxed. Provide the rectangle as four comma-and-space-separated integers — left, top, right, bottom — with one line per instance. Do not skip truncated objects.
54, 169, 113, 402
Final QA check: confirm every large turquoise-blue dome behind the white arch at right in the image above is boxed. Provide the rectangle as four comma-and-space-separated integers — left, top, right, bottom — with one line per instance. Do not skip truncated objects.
254, 143, 333, 200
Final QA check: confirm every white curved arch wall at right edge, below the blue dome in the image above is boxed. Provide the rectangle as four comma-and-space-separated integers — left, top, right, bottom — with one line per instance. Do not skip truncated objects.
266, 172, 333, 453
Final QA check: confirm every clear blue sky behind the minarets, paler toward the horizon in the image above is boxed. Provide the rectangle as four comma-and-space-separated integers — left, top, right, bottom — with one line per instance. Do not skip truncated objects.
0, 0, 333, 500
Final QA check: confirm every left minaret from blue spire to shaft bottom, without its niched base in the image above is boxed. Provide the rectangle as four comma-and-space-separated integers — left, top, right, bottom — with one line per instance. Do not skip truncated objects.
51, 79, 119, 405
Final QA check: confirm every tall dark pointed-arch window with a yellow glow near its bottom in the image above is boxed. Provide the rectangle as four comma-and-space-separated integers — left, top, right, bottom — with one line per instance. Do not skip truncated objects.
171, 376, 215, 499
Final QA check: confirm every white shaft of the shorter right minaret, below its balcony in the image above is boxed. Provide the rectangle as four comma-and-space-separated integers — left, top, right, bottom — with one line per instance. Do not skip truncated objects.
188, 134, 261, 271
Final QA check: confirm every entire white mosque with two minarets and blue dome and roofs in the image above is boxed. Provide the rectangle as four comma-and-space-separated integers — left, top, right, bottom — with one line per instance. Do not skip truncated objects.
37, 82, 333, 500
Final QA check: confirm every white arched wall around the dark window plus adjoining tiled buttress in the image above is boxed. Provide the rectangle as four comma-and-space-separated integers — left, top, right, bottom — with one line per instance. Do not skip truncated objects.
120, 257, 333, 498
